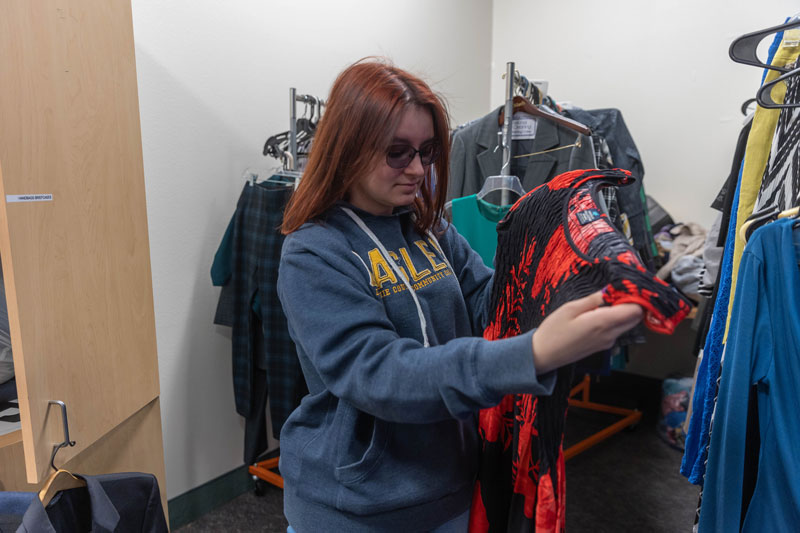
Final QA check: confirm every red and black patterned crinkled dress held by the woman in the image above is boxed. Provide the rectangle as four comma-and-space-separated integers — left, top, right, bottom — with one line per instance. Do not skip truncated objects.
469, 169, 690, 532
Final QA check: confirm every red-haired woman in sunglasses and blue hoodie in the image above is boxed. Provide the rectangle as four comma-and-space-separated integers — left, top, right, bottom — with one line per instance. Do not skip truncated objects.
278, 60, 642, 533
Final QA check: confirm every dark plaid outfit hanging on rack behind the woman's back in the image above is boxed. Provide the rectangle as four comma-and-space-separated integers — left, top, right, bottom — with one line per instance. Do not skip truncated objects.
211, 180, 306, 463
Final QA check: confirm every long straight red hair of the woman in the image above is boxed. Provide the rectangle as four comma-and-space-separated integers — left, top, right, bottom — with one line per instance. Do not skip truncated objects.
281, 60, 450, 235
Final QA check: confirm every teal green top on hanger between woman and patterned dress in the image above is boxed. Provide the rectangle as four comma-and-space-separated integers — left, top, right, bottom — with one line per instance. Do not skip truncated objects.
450, 194, 511, 268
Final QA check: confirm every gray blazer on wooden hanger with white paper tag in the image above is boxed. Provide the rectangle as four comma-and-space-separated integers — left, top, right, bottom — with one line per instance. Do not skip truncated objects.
447, 106, 597, 200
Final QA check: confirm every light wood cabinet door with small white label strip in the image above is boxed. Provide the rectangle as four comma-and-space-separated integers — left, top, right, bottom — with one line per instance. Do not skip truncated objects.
0, 0, 158, 483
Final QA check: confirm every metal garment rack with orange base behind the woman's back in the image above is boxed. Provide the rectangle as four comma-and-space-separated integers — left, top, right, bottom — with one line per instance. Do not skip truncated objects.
252, 87, 325, 495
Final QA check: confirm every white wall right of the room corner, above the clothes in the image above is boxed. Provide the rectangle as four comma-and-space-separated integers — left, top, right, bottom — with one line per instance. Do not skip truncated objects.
491, 0, 800, 227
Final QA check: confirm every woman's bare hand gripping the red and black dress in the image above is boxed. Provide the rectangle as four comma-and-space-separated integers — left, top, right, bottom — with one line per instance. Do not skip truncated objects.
533, 292, 644, 374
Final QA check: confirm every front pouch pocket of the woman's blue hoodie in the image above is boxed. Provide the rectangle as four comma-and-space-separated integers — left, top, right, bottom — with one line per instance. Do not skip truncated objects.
334, 402, 390, 485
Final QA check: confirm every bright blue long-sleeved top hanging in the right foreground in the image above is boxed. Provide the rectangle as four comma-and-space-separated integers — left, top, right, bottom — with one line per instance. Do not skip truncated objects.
699, 219, 800, 533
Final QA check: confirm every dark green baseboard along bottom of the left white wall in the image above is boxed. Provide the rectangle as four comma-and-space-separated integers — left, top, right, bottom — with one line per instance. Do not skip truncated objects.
168, 450, 279, 531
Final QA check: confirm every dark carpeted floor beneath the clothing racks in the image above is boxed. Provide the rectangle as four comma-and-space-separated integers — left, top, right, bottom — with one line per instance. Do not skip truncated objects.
176, 372, 698, 533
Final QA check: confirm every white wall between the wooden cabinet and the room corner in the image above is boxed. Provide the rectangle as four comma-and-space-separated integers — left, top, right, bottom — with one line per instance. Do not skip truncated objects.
133, 0, 492, 498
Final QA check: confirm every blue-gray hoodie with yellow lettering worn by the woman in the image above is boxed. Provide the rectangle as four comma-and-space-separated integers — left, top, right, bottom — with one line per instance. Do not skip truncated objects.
278, 203, 554, 533
